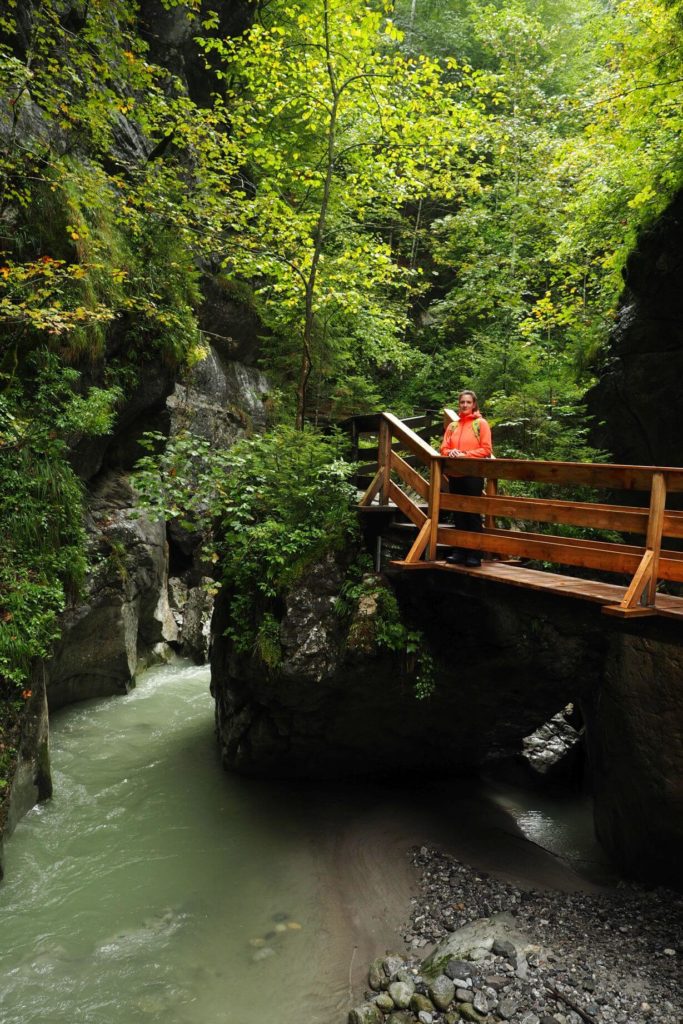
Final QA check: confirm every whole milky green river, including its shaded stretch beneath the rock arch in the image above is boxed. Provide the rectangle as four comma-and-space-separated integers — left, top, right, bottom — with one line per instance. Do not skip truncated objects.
0, 663, 614, 1024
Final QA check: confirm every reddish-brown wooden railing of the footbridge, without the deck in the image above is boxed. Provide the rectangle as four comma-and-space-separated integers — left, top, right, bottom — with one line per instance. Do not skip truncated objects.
359, 410, 683, 615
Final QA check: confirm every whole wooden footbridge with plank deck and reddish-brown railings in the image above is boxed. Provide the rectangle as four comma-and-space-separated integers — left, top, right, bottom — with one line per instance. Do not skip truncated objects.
351, 409, 683, 618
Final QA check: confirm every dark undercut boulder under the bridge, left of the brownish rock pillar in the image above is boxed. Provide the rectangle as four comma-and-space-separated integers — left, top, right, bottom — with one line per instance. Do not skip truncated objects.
211, 558, 600, 777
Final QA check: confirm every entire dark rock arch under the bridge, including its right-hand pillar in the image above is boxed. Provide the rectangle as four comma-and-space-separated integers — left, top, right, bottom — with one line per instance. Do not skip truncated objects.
211, 558, 683, 884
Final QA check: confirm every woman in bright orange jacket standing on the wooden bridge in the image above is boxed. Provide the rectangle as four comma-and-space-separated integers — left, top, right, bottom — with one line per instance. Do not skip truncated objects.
440, 390, 494, 567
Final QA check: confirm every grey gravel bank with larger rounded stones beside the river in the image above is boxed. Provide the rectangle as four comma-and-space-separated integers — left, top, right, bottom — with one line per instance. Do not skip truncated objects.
349, 847, 683, 1024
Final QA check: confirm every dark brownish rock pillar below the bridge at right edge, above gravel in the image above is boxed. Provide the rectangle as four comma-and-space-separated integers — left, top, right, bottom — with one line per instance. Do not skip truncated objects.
584, 635, 683, 887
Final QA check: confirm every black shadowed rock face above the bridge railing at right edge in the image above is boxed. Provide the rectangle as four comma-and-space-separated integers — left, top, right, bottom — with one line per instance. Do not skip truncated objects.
588, 193, 683, 466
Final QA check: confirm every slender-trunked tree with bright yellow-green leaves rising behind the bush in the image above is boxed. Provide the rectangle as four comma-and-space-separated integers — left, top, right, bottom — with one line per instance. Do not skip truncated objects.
197, 0, 480, 427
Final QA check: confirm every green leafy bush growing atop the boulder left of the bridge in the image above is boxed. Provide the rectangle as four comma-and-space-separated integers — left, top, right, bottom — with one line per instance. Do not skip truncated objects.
135, 426, 357, 666
